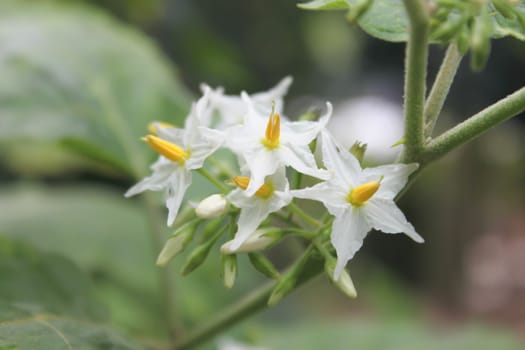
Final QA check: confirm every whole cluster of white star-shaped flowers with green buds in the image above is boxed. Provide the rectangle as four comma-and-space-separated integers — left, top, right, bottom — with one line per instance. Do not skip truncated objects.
126, 77, 423, 294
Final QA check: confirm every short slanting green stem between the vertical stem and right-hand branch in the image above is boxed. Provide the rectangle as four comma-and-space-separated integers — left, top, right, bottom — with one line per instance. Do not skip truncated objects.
424, 44, 463, 137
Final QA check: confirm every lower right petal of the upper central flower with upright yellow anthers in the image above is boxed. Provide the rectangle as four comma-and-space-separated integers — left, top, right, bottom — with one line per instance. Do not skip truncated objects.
276, 145, 330, 179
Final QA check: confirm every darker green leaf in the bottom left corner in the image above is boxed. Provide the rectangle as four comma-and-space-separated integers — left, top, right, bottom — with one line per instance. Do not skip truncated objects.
0, 238, 141, 350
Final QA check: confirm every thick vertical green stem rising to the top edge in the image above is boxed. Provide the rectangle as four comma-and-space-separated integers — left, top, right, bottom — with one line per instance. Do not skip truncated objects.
403, 0, 429, 162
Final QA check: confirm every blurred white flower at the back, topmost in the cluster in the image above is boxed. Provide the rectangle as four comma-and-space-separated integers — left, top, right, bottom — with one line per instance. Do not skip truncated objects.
201, 77, 292, 130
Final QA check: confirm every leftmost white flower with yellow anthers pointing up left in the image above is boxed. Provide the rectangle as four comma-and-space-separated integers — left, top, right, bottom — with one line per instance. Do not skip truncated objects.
125, 91, 223, 226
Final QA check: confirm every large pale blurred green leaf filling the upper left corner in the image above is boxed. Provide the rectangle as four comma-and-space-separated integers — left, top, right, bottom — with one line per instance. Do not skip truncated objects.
0, 1, 189, 177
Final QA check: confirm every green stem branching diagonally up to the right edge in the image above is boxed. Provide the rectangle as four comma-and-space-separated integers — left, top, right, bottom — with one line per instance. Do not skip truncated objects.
421, 87, 525, 164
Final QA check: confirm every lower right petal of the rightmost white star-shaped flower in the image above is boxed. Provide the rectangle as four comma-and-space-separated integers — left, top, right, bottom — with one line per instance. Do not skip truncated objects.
361, 198, 424, 243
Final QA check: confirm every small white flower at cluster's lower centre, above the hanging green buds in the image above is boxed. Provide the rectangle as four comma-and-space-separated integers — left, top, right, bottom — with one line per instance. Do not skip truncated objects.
226, 168, 293, 252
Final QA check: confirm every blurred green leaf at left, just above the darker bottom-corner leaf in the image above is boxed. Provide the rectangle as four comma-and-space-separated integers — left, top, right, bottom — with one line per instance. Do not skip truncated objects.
0, 185, 164, 335
